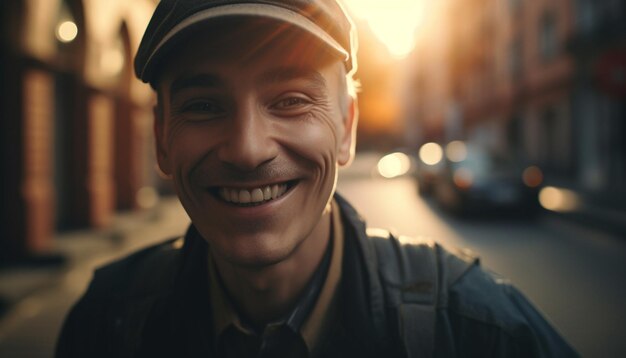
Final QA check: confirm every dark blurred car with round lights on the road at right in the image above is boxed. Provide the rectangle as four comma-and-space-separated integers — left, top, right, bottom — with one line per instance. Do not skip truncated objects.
433, 145, 543, 215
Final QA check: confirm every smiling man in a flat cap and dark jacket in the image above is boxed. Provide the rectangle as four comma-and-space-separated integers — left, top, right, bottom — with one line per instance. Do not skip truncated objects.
57, 0, 575, 357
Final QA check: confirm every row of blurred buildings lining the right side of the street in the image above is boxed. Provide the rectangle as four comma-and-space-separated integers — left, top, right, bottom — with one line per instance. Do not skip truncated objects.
410, 0, 626, 216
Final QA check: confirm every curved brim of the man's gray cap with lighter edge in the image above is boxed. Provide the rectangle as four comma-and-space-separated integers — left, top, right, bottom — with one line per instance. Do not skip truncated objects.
139, 4, 350, 82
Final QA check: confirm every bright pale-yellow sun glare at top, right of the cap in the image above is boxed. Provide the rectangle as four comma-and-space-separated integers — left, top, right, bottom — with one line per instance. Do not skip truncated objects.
343, 0, 424, 59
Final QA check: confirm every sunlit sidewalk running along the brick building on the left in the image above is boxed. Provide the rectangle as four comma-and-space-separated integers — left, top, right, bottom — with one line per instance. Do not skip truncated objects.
0, 197, 189, 322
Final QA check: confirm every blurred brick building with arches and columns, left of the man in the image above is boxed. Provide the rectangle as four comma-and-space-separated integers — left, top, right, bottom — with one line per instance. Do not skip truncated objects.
0, 0, 161, 263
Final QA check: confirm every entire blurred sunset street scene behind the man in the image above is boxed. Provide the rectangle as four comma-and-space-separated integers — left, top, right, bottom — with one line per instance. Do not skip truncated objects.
0, 0, 626, 357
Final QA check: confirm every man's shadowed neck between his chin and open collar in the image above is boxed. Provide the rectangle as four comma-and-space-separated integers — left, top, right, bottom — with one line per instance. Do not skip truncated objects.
213, 212, 331, 327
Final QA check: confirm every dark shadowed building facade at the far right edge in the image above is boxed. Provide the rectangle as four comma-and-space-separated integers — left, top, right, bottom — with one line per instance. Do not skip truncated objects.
567, 0, 626, 216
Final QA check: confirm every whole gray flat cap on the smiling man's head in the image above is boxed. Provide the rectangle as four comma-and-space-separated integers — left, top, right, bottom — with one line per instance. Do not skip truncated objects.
135, 0, 356, 83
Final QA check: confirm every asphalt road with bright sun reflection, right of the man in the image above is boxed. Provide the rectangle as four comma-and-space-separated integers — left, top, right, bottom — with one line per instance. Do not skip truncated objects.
338, 172, 626, 358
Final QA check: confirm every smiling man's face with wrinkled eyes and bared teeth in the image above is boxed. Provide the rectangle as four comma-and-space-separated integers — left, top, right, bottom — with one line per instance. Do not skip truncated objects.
155, 22, 354, 266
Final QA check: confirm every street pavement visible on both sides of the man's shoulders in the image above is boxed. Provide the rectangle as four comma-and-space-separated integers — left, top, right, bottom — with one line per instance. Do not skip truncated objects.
0, 162, 626, 357
